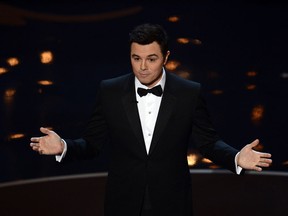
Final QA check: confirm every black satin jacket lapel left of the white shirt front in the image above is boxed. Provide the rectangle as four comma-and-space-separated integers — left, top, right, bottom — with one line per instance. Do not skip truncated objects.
122, 76, 146, 153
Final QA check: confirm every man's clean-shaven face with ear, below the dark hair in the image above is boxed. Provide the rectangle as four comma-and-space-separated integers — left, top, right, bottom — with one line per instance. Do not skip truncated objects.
130, 41, 169, 88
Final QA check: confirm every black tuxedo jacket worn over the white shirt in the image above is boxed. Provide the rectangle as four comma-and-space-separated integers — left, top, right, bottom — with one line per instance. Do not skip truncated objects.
66, 72, 238, 216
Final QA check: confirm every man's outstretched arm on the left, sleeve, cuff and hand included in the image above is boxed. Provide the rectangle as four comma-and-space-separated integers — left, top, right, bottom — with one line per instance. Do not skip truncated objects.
30, 84, 107, 161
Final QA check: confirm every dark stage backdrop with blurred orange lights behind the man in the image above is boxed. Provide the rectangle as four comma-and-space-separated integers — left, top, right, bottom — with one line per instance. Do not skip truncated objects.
0, 0, 288, 182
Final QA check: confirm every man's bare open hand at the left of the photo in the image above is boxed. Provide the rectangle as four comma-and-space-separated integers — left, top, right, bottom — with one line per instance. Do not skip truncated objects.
30, 127, 64, 155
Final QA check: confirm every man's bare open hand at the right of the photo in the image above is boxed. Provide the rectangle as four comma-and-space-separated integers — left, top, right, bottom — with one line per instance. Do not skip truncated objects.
237, 139, 272, 172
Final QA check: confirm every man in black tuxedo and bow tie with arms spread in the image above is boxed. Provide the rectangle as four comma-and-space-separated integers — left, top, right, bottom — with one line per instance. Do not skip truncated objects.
30, 24, 272, 216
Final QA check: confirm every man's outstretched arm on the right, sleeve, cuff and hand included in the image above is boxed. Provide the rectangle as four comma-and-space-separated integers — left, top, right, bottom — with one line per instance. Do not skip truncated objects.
194, 87, 272, 174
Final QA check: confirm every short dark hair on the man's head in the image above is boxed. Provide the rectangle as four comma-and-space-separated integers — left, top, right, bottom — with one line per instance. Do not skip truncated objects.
129, 23, 168, 56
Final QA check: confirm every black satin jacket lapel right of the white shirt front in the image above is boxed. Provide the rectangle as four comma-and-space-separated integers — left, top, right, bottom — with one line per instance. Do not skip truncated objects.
149, 77, 176, 154
